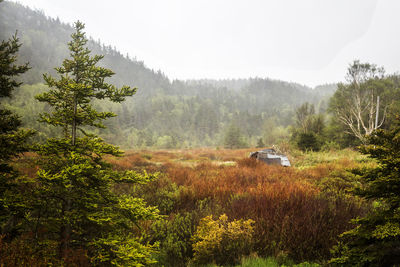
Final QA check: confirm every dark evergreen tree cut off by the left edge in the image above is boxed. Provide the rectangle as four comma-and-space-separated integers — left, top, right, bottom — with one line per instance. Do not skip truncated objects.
0, 35, 33, 237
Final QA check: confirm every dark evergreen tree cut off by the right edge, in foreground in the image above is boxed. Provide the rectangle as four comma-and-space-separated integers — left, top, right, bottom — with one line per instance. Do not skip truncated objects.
332, 118, 400, 266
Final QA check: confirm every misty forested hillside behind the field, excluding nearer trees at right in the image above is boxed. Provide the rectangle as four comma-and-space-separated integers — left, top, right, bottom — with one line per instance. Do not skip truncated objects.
0, 2, 336, 148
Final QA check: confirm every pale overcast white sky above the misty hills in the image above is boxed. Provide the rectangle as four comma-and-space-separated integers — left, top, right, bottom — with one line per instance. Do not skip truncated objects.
9, 0, 400, 86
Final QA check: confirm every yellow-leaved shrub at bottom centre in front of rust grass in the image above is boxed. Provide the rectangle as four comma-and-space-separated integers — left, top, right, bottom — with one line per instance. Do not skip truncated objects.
193, 214, 254, 265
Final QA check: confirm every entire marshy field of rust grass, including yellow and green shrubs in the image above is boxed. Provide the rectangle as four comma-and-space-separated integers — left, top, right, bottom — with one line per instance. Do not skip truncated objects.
10, 148, 375, 266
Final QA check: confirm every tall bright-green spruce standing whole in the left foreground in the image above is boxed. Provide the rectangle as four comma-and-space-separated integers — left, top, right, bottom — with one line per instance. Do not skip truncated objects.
31, 21, 157, 266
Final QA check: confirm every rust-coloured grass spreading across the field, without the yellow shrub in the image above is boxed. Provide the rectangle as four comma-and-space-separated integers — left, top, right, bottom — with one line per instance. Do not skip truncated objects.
113, 149, 365, 261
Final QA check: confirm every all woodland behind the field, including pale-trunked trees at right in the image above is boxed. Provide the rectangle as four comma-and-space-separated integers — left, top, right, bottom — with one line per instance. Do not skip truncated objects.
0, 2, 400, 153
